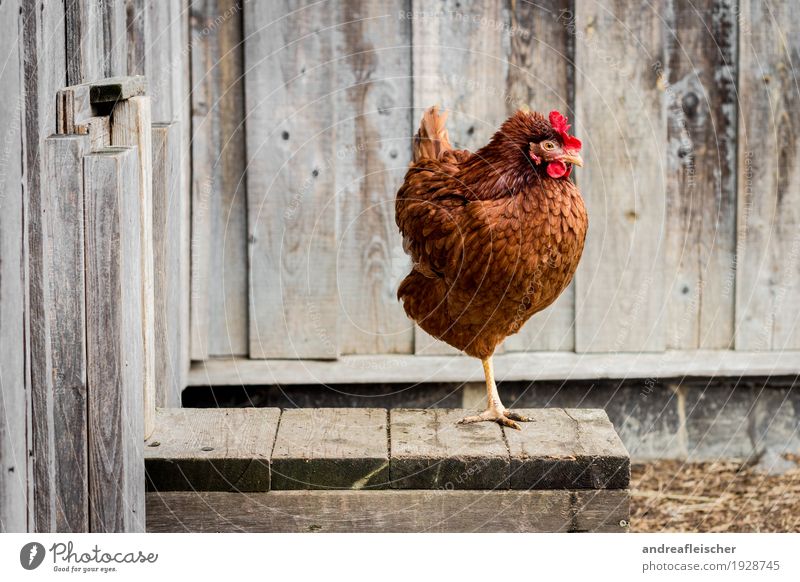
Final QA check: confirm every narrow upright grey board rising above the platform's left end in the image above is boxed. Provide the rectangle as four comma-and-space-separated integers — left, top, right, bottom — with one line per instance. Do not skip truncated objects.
153, 123, 189, 407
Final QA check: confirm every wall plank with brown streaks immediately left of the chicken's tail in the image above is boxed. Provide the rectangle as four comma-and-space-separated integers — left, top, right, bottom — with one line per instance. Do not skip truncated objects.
336, 0, 414, 354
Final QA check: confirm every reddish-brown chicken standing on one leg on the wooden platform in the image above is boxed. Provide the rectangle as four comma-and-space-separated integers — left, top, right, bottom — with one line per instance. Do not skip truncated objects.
395, 107, 588, 429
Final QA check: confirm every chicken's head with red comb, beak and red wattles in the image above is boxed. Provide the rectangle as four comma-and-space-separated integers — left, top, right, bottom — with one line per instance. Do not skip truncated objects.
528, 111, 583, 178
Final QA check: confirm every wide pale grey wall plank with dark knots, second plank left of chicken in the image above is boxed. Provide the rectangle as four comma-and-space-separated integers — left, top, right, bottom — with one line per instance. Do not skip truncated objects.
244, 0, 339, 358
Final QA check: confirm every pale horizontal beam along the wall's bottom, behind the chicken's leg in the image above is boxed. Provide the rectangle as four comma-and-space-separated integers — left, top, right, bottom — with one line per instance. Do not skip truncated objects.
188, 350, 800, 386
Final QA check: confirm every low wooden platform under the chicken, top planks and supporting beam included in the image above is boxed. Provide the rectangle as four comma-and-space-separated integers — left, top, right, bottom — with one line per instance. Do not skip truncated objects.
145, 408, 630, 531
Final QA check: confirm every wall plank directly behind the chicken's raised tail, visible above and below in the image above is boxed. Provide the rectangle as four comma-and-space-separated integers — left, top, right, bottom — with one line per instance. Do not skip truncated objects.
406, 0, 510, 355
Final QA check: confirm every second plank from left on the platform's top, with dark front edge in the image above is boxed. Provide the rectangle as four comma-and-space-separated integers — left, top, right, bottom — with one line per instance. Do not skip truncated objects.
272, 408, 389, 489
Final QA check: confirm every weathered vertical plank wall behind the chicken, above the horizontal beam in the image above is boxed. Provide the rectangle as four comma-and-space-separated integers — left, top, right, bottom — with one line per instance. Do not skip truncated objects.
181, 0, 800, 359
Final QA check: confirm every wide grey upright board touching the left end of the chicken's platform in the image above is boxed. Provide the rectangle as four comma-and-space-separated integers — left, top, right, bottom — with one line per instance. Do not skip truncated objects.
84, 147, 147, 532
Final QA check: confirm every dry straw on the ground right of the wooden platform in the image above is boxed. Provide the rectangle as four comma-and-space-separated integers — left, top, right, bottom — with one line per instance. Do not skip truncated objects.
631, 457, 800, 532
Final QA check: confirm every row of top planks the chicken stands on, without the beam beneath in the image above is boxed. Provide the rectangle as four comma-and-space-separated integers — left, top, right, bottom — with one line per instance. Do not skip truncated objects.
145, 408, 630, 491
